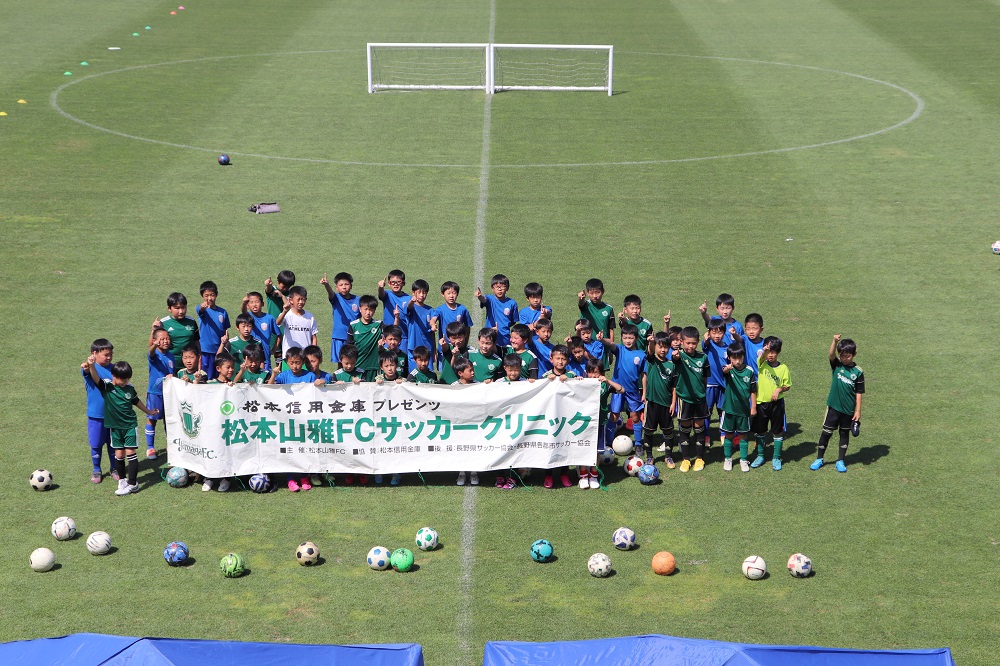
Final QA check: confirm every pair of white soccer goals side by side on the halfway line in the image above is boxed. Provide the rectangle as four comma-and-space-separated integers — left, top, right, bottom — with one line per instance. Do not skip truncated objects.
368, 43, 614, 95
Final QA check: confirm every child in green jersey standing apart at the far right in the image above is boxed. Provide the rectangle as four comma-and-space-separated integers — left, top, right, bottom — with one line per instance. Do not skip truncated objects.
809, 333, 865, 472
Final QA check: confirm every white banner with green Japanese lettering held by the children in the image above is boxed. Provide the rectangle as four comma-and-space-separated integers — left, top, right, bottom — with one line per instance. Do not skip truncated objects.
163, 379, 600, 478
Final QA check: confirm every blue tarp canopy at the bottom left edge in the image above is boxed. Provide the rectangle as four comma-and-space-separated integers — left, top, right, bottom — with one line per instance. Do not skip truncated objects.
0, 634, 424, 666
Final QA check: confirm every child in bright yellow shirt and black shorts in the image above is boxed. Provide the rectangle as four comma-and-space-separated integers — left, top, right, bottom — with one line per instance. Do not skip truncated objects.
752, 335, 792, 472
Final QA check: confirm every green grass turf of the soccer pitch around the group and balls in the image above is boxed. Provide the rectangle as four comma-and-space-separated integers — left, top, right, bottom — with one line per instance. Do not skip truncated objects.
0, 0, 1000, 666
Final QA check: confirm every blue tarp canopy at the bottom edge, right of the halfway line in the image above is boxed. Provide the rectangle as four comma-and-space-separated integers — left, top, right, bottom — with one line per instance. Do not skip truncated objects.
483, 635, 955, 666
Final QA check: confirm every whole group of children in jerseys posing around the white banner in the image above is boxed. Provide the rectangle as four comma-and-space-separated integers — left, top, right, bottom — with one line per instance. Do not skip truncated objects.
81, 270, 864, 495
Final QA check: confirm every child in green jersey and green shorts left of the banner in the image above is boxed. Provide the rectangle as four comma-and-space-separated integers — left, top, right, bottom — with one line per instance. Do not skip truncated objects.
85, 354, 159, 496
